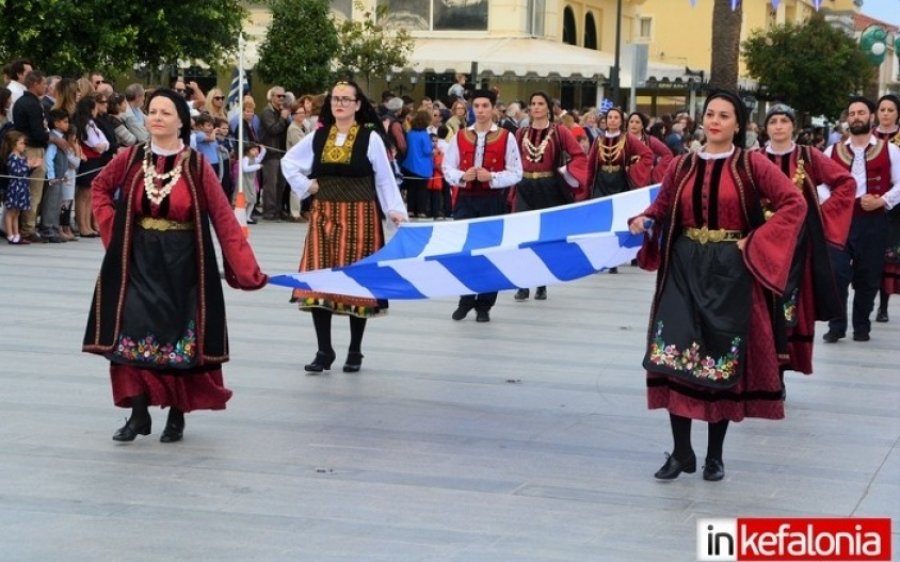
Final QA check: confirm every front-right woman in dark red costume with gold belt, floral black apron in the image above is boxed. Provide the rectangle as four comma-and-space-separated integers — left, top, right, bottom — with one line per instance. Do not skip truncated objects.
629, 91, 806, 481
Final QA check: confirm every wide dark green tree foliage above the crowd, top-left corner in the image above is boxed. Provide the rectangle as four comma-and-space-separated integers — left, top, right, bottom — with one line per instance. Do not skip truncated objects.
0, 0, 246, 75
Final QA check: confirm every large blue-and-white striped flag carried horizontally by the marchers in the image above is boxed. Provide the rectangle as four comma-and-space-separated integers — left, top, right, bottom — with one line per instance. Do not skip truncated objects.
269, 185, 659, 299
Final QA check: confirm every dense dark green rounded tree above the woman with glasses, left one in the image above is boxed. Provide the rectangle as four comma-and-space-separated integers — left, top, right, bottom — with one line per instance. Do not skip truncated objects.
256, 0, 338, 94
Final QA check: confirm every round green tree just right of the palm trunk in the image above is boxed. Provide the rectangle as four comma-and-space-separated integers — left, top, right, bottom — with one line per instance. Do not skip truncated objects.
743, 15, 875, 119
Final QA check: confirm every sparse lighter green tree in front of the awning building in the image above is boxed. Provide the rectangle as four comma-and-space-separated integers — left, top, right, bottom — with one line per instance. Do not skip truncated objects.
337, 2, 415, 92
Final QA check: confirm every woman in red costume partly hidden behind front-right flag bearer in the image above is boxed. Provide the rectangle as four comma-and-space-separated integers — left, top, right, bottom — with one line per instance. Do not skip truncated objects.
763, 103, 856, 374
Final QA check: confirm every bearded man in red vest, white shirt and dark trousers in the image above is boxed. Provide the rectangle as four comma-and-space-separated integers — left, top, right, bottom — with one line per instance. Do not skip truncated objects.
823, 96, 900, 343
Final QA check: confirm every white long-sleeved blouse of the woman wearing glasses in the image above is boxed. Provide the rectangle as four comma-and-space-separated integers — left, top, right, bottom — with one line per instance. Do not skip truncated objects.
281, 127, 407, 217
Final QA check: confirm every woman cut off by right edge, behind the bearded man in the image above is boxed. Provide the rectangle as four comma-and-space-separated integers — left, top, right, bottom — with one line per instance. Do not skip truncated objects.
872, 94, 900, 322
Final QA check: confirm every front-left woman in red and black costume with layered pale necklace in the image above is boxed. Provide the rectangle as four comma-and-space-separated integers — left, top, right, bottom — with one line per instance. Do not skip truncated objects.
83, 89, 268, 443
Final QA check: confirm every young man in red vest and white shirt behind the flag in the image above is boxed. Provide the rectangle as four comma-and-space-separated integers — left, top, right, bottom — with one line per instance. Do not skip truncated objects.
443, 90, 522, 322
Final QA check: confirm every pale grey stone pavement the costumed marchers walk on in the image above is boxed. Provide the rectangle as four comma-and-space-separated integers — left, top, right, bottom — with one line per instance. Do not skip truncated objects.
0, 223, 900, 562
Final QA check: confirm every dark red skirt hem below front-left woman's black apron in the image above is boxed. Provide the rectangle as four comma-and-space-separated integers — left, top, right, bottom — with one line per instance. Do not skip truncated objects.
109, 364, 232, 412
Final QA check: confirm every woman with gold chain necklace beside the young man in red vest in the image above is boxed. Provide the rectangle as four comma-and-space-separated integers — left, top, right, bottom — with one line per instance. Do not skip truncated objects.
514, 92, 587, 301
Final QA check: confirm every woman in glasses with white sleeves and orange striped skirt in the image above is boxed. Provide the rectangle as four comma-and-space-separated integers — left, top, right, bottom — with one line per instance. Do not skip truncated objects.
281, 82, 406, 373
